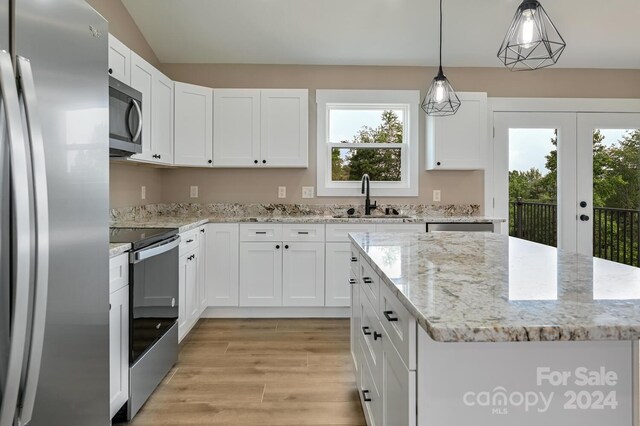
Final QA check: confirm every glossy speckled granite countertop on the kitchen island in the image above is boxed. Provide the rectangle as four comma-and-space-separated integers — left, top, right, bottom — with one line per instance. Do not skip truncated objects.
351, 232, 640, 342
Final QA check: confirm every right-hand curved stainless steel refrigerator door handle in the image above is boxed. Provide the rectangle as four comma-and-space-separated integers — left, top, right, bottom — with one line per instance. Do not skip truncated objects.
17, 56, 49, 425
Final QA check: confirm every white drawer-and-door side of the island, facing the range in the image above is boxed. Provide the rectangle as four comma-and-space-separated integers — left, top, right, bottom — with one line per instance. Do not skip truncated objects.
345, 247, 417, 426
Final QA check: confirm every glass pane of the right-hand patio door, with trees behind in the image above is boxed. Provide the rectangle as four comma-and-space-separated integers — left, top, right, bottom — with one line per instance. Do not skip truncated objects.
593, 129, 640, 266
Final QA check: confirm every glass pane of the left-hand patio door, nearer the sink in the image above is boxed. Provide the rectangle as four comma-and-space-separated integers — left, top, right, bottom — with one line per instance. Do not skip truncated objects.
509, 129, 558, 247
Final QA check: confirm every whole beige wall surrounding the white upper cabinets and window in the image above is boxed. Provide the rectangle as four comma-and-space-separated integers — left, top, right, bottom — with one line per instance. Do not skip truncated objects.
97, 0, 640, 211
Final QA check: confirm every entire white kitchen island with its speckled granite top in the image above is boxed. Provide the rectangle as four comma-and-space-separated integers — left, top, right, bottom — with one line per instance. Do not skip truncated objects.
349, 232, 640, 426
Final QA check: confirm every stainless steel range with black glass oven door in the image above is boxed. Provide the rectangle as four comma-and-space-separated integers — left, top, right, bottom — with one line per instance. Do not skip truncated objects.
110, 228, 180, 420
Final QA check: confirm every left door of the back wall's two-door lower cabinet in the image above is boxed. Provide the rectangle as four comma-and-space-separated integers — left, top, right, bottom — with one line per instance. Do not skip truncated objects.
240, 242, 283, 306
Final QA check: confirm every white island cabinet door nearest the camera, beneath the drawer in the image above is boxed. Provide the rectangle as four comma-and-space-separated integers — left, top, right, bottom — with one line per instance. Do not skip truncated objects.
380, 339, 416, 426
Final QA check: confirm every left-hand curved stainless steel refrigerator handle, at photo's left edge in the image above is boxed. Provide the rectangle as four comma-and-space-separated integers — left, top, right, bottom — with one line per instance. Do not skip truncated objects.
0, 50, 33, 426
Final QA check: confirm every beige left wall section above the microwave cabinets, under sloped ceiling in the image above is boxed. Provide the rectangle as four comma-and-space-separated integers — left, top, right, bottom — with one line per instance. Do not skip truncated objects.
86, 0, 160, 68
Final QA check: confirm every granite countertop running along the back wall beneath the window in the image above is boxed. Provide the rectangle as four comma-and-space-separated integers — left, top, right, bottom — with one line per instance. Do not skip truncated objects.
111, 215, 504, 232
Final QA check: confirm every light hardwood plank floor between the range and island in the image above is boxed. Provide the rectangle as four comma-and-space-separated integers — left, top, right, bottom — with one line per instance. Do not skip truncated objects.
125, 319, 365, 426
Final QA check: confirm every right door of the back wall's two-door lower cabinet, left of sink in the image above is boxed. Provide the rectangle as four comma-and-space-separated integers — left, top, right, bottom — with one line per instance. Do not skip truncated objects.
282, 242, 324, 306
